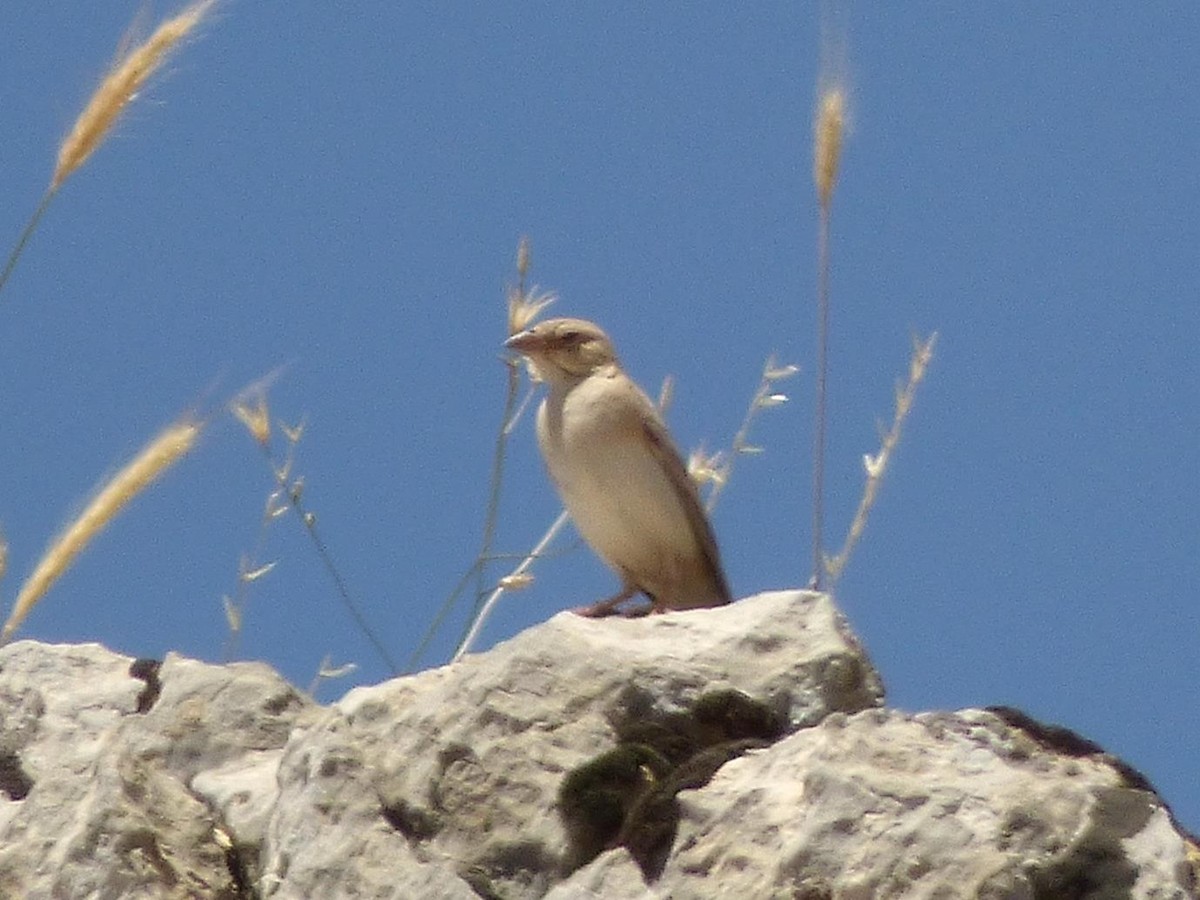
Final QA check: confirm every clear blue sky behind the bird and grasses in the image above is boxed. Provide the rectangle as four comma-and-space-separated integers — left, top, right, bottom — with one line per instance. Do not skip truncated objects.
0, 0, 1200, 829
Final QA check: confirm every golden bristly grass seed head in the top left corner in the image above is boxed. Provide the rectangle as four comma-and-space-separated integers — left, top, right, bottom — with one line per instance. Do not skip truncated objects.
50, 0, 216, 193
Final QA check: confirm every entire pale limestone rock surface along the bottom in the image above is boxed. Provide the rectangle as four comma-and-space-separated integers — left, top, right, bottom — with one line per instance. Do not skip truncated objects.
0, 592, 1198, 900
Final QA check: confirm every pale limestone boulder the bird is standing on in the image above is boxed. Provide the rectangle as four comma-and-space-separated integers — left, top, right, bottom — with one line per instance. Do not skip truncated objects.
265, 592, 882, 898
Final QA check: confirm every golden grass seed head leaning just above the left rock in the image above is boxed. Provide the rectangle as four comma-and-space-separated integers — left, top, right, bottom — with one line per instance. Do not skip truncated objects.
0, 419, 202, 644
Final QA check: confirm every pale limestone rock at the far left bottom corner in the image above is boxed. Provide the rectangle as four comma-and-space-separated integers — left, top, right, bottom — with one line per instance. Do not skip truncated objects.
0, 641, 312, 899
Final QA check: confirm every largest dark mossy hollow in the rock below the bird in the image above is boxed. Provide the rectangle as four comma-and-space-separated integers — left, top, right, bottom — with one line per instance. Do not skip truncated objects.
558, 690, 784, 881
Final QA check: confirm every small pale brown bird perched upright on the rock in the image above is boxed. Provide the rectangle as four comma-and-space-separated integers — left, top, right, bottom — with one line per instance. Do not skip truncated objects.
505, 318, 732, 618
